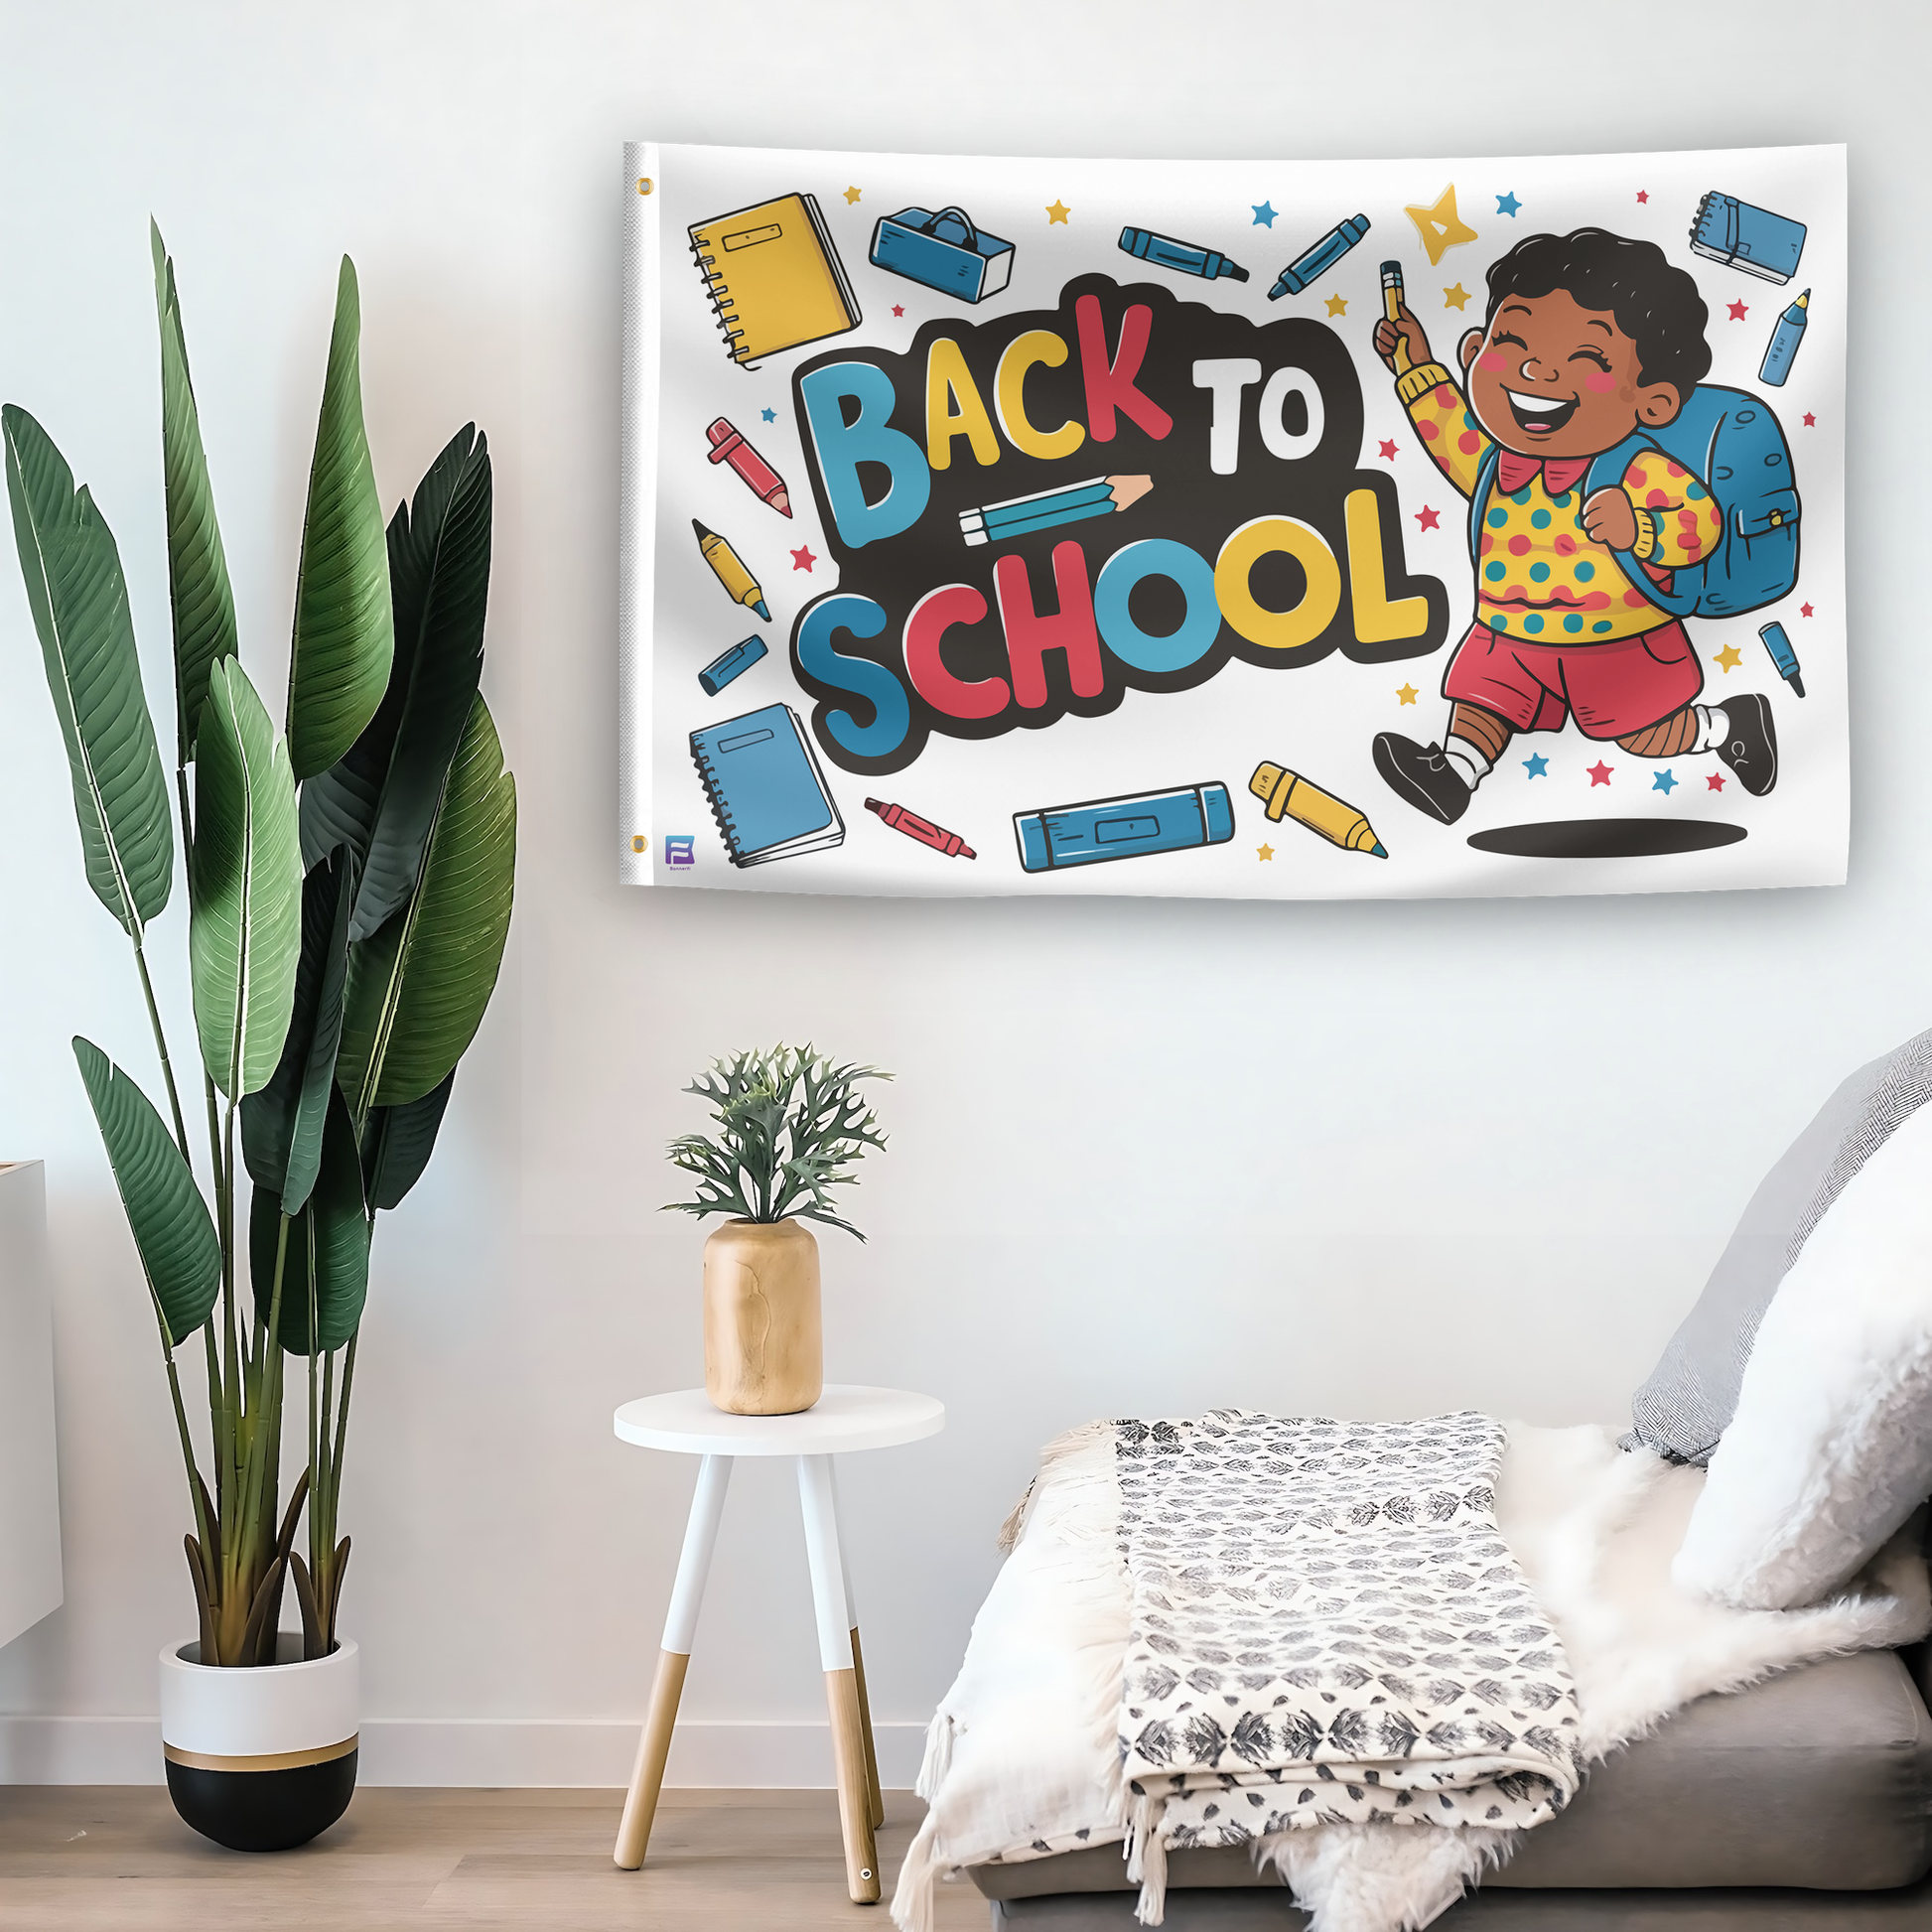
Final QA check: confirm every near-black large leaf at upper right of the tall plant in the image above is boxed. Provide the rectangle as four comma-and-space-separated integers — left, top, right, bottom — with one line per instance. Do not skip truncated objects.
302, 423, 492, 939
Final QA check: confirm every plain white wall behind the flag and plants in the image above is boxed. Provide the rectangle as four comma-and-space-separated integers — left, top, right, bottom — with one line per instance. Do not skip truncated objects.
0, 0, 1932, 1783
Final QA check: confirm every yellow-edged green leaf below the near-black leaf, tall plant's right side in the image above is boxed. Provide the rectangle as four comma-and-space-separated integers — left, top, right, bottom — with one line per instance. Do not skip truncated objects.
337, 698, 516, 1121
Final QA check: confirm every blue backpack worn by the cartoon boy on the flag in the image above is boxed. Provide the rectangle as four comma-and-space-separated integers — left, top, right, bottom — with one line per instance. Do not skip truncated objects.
1468, 382, 1799, 617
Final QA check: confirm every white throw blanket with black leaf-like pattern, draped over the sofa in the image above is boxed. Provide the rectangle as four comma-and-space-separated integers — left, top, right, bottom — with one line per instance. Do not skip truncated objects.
1113, 1411, 1583, 1922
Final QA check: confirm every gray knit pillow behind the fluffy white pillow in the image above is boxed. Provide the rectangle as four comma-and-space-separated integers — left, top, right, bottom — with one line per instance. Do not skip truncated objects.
1623, 1030, 1932, 1462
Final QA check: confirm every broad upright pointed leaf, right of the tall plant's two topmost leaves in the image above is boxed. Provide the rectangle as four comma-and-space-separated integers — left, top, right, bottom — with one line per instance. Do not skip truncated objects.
288, 255, 396, 778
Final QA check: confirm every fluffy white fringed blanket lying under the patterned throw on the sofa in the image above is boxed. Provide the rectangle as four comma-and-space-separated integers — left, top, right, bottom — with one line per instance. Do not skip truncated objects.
893, 1424, 1932, 1932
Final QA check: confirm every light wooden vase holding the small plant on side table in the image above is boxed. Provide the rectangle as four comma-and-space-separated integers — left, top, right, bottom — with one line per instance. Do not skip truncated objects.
705, 1221, 825, 1416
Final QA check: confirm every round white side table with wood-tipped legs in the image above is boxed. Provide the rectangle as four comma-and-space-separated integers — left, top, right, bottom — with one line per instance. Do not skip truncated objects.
613, 1383, 947, 1905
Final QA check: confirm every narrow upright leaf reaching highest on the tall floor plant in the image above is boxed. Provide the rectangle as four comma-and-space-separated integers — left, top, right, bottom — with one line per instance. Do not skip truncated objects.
149, 222, 235, 765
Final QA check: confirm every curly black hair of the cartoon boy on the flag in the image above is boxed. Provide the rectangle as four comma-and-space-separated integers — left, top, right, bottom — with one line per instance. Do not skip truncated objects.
1484, 228, 1710, 400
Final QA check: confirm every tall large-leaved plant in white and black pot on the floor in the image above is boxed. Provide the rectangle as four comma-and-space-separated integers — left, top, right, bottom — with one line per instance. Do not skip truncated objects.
0, 230, 516, 1851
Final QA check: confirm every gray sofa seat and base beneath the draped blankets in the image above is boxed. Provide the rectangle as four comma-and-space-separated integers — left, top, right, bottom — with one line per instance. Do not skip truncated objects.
970, 1646, 1932, 1932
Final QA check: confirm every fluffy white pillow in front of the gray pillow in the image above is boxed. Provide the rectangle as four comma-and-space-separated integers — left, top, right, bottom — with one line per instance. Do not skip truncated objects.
1671, 1107, 1932, 1609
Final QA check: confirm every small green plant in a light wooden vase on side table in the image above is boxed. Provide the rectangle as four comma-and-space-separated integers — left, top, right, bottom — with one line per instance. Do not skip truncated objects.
664, 1043, 893, 1416
